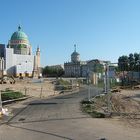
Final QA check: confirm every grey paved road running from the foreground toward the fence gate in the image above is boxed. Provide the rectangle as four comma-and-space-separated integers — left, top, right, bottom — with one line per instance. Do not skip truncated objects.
0, 89, 139, 140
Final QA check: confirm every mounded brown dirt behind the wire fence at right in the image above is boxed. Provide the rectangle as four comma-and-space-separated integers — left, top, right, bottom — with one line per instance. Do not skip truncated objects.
93, 88, 140, 129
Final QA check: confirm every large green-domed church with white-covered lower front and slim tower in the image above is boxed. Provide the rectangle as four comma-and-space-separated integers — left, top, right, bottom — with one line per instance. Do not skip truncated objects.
0, 26, 41, 77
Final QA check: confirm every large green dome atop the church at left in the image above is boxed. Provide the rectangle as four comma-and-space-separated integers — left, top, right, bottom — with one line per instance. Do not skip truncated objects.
11, 26, 28, 40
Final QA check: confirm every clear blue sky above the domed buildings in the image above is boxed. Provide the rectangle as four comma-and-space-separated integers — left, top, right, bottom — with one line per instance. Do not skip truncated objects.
0, 0, 140, 66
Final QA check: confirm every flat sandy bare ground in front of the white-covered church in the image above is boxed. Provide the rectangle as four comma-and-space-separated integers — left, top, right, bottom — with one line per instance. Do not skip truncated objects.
0, 80, 58, 98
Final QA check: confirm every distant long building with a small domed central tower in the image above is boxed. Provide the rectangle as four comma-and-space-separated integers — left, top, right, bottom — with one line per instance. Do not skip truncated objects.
64, 46, 110, 84
